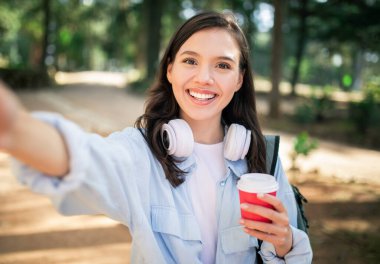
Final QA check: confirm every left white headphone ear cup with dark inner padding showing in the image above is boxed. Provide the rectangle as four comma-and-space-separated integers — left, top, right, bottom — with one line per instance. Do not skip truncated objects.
161, 119, 194, 158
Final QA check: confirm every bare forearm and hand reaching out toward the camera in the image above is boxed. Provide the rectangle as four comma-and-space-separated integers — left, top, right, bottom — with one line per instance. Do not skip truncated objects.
0, 80, 69, 176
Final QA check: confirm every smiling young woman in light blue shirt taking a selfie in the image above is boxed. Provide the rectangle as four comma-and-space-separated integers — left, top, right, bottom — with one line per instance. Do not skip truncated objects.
0, 12, 312, 263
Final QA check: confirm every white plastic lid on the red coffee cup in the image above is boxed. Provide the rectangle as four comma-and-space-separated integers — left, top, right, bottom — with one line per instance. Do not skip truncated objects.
237, 173, 278, 193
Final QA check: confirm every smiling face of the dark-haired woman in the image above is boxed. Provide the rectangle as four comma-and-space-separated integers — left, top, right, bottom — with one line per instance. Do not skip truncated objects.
167, 28, 243, 132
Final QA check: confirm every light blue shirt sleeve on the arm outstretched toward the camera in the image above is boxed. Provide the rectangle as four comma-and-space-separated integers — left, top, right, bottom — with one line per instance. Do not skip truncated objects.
13, 112, 150, 223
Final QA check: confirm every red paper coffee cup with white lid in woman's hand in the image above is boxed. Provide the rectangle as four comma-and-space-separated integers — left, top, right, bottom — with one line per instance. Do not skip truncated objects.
237, 173, 278, 223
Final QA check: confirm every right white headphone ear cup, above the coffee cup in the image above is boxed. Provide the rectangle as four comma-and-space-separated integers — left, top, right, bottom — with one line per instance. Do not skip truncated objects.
224, 124, 251, 161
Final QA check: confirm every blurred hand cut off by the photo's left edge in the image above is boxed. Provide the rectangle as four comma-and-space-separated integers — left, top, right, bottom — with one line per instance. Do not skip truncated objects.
0, 80, 22, 150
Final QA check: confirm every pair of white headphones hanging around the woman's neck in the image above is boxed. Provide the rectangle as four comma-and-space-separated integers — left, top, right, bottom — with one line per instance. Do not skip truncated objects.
161, 119, 251, 161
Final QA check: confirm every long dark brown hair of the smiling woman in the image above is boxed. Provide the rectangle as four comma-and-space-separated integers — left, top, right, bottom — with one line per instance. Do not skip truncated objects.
135, 12, 266, 187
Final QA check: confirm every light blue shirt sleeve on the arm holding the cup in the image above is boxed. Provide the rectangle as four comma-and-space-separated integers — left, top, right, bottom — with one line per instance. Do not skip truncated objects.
259, 159, 313, 264
